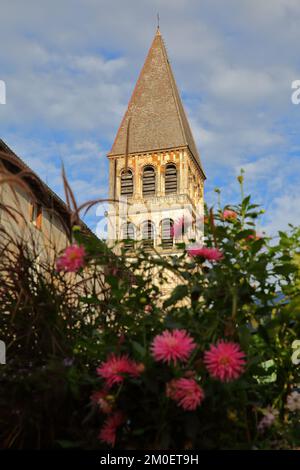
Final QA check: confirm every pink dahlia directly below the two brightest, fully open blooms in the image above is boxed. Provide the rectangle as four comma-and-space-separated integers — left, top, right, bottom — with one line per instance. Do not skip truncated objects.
166, 378, 204, 411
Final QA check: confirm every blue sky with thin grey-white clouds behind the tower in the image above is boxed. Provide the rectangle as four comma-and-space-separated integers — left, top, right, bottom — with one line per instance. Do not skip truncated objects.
0, 0, 300, 233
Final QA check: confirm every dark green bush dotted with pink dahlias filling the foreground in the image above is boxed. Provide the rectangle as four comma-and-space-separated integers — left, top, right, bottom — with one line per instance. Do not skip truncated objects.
0, 174, 300, 449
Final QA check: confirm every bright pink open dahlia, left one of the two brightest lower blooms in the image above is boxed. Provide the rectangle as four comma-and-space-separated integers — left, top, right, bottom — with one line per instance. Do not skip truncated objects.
151, 330, 196, 365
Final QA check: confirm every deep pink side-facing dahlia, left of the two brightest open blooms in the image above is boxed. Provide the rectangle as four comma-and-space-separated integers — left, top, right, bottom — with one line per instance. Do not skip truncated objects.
96, 354, 141, 387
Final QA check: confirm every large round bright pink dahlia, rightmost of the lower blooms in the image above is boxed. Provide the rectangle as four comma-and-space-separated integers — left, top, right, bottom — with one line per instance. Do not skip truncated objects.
204, 341, 246, 382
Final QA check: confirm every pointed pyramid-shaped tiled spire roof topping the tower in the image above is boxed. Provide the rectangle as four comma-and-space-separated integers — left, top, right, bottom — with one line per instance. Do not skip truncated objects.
110, 28, 201, 173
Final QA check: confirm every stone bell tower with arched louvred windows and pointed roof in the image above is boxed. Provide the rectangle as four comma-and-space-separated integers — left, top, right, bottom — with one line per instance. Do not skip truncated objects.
108, 29, 205, 254
